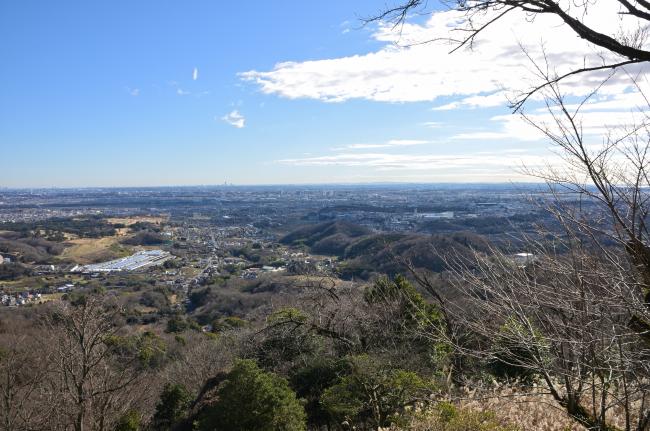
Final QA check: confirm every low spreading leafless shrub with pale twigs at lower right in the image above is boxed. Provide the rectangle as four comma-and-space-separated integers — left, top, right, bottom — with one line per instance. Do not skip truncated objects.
436, 231, 650, 430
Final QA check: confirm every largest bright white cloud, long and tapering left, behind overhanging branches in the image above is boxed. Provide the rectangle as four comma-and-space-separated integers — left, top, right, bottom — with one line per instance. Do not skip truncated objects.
240, 0, 644, 105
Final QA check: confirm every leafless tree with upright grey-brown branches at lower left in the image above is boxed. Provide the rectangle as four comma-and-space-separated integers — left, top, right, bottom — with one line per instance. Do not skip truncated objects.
45, 297, 144, 431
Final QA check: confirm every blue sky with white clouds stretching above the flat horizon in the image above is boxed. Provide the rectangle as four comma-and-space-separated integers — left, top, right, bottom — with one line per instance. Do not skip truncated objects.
0, 0, 628, 187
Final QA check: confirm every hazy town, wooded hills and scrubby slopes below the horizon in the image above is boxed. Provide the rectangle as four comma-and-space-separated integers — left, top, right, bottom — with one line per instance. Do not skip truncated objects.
0, 185, 616, 430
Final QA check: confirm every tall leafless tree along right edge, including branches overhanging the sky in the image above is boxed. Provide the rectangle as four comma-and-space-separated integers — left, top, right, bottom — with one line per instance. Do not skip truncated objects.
360, 0, 650, 431
